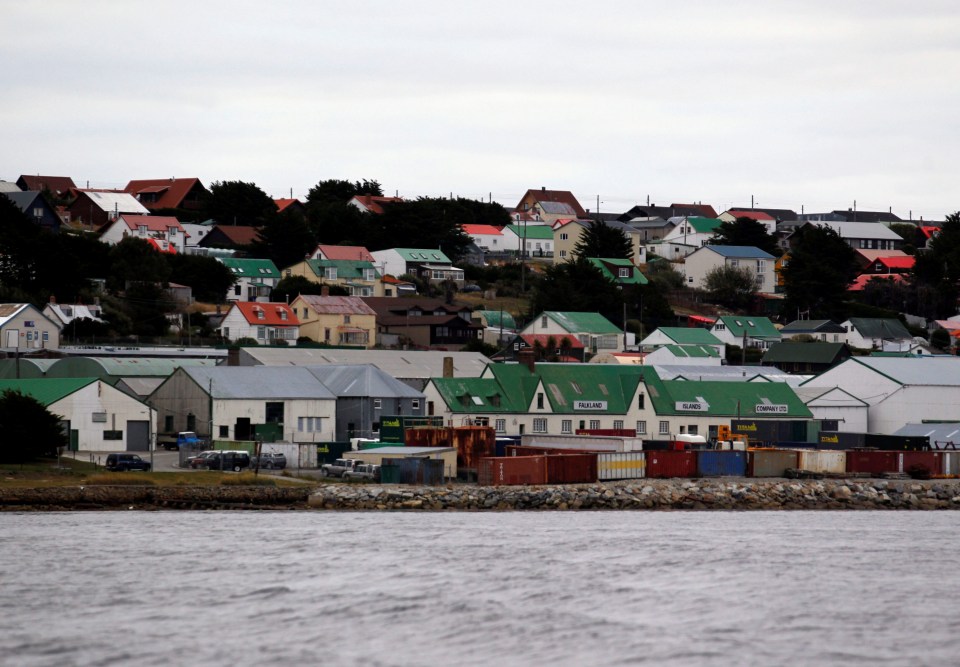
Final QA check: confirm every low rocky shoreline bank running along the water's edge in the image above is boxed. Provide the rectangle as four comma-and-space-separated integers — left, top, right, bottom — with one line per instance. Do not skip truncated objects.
0, 478, 960, 511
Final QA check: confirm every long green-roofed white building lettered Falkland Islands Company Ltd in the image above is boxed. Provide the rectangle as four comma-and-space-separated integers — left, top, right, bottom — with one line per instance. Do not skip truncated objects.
423, 360, 811, 440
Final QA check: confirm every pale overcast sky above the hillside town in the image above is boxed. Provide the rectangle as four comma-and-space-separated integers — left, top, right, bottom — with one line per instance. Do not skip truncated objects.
0, 0, 960, 220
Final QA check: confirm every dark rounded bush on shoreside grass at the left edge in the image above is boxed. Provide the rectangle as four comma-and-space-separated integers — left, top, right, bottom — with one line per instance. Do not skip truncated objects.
0, 389, 68, 463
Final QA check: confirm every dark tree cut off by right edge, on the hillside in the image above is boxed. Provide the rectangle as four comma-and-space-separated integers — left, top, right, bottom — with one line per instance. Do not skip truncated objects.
913, 211, 960, 319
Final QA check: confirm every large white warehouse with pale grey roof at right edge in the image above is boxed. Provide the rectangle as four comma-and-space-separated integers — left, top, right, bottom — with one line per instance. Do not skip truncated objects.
801, 356, 960, 433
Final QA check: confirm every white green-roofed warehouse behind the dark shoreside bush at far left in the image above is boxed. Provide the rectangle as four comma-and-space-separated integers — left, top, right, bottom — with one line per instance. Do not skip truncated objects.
0, 377, 156, 452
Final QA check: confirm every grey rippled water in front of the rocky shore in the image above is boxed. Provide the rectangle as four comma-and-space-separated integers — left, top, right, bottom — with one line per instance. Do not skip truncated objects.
0, 512, 960, 667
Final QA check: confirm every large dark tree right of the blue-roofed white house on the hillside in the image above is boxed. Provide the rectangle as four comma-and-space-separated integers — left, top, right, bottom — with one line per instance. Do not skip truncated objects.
781, 224, 860, 322
